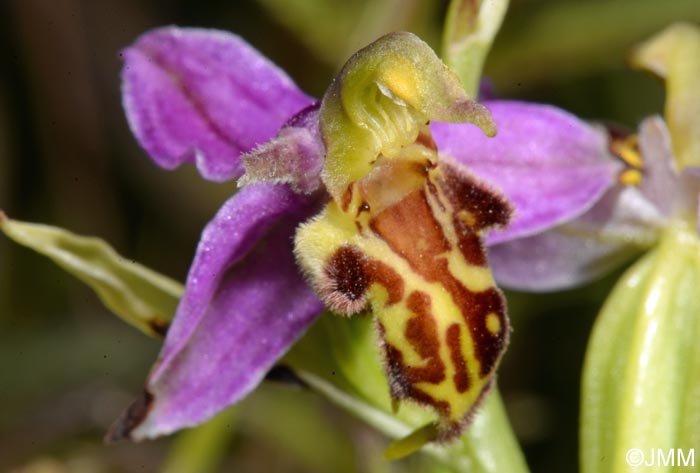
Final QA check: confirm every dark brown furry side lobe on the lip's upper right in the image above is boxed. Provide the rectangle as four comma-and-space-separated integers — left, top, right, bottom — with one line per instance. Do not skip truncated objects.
437, 161, 513, 231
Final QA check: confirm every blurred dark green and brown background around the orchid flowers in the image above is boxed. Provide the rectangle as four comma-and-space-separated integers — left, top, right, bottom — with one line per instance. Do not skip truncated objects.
0, 0, 700, 473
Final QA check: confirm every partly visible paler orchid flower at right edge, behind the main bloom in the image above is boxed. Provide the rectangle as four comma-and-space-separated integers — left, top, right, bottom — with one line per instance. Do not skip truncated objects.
482, 25, 700, 291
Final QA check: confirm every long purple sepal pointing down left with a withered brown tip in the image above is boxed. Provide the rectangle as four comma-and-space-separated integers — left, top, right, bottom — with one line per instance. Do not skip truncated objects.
110, 184, 323, 440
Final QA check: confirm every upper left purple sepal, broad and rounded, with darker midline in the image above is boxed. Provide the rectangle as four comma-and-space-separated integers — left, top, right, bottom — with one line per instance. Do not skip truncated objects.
122, 27, 312, 181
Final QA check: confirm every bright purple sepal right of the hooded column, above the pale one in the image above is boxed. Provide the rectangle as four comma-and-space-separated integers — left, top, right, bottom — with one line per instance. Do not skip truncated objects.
431, 100, 619, 244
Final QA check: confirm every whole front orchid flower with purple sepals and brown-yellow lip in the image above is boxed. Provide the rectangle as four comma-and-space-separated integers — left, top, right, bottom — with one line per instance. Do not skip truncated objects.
110, 27, 620, 440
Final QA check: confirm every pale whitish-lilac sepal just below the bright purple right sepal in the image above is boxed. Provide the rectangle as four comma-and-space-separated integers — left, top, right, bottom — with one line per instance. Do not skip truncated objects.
489, 186, 665, 292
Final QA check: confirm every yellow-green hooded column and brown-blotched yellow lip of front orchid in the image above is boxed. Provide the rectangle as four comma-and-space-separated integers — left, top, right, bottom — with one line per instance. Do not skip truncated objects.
295, 33, 512, 440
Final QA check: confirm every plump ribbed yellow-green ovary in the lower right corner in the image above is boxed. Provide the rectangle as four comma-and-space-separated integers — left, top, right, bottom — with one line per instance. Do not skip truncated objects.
581, 222, 700, 473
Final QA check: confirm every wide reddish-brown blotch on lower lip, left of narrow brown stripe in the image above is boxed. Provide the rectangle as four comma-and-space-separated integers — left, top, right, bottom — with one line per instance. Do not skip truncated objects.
405, 292, 445, 384
